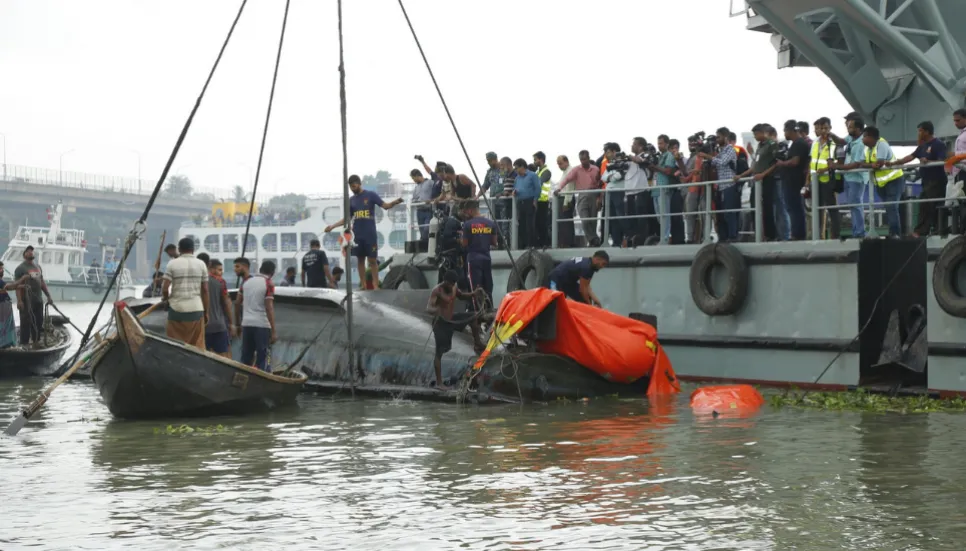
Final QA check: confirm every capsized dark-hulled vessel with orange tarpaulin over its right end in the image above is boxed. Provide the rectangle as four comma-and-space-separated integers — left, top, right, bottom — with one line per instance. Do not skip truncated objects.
130, 287, 677, 403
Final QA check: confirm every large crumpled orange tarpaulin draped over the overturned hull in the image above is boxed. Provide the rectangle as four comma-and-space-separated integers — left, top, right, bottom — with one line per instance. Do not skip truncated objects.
475, 288, 680, 395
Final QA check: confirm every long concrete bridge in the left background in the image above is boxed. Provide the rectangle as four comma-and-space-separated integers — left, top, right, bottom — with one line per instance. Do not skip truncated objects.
0, 165, 232, 277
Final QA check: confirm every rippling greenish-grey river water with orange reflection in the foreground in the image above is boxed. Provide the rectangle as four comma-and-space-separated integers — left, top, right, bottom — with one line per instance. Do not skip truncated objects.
0, 305, 966, 551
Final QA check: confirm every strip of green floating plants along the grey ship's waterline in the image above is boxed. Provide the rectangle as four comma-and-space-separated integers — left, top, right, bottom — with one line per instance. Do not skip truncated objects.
768, 389, 966, 414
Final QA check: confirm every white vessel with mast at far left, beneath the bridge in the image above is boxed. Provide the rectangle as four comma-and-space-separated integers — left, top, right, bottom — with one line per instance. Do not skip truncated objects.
3, 203, 137, 303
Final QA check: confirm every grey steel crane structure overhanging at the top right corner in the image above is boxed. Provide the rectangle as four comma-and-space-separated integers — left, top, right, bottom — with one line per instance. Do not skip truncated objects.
731, 0, 966, 145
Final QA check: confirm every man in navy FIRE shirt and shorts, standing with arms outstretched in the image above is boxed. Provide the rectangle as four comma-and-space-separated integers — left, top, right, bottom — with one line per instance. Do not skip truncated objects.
324, 174, 402, 289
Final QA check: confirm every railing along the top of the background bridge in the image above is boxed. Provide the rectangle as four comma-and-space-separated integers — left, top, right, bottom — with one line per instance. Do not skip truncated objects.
0, 165, 240, 200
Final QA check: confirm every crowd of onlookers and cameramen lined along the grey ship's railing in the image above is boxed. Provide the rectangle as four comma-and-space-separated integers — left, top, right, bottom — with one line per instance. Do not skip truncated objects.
410, 109, 966, 249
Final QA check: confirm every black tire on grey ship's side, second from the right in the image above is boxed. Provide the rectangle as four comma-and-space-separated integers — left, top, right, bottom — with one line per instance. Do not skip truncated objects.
688, 243, 748, 316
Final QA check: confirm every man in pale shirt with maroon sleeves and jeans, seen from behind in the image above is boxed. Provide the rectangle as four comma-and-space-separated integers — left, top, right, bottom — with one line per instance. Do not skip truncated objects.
235, 260, 278, 371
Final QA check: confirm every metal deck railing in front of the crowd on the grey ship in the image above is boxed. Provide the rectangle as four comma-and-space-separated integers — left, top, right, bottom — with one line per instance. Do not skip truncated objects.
398, 161, 966, 250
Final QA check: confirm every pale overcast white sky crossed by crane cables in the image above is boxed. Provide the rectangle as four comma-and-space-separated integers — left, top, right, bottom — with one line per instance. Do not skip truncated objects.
0, 0, 851, 198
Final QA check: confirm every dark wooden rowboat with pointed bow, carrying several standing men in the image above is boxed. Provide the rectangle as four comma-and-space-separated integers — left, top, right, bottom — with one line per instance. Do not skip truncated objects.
91, 302, 306, 419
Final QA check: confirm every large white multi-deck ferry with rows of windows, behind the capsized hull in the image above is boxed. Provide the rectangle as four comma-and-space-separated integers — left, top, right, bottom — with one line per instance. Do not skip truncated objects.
178, 182, 417, 282
